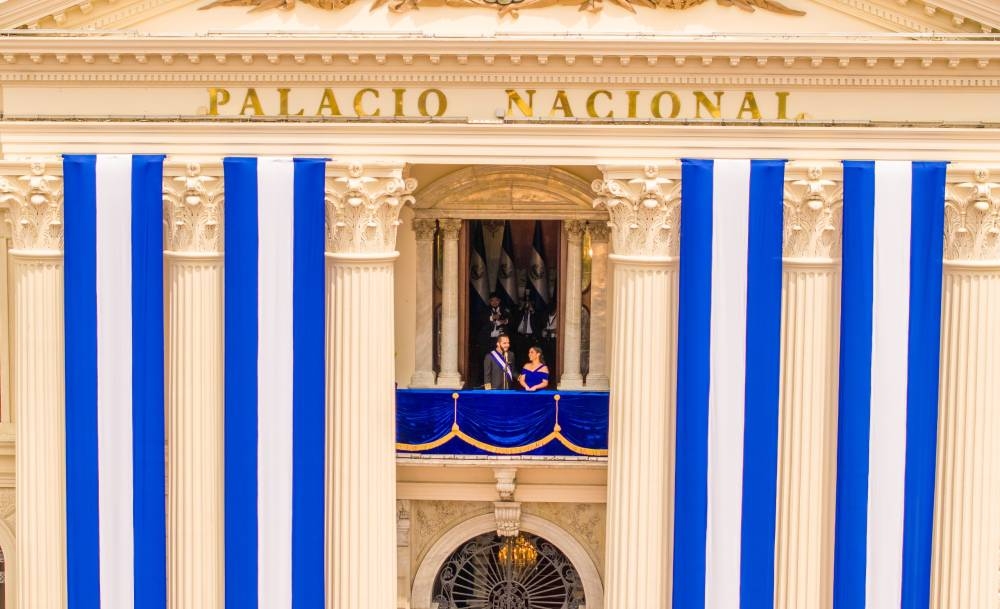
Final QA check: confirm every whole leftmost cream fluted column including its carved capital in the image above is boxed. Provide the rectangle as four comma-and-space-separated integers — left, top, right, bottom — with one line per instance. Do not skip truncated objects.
0, 163, 66, 609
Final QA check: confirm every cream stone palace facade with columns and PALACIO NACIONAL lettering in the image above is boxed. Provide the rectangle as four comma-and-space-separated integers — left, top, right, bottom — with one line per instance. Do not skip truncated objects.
0, 0, 1000, 609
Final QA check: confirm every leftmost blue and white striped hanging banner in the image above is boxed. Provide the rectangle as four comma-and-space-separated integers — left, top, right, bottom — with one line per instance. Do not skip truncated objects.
64, 155, 167, 609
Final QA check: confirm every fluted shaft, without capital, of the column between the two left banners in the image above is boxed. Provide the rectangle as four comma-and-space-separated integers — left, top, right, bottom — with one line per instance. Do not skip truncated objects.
166, 251, 224, 609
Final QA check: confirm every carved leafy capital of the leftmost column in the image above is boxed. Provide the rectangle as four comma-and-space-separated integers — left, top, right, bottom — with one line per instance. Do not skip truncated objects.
0, 163, 63, 250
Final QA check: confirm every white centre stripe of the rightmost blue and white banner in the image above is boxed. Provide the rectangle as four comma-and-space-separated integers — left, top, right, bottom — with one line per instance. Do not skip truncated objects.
865, 161, 913, 609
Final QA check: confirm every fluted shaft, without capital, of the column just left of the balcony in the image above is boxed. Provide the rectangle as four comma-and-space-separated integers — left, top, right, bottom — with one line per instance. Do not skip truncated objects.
326, 253, 397, 609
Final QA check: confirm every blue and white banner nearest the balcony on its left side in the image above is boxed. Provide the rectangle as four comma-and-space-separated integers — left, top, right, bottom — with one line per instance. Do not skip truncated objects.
223, 158, 326, 609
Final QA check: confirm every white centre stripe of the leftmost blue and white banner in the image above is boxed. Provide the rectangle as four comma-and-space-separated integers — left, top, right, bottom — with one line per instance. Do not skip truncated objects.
95, 155, 135, 609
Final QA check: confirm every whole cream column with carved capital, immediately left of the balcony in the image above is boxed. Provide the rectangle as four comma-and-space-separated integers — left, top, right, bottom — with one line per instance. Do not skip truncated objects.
326, 165, 417, 609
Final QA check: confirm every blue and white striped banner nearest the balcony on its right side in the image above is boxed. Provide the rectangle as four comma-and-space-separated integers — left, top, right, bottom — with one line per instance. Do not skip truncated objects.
673, 160, 785, 609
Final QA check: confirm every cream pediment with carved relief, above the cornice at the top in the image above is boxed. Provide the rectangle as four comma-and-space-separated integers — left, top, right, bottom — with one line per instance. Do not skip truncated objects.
0, 0, 1000, 36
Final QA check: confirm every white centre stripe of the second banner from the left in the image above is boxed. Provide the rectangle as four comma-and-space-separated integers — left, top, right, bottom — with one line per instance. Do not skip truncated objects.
257, 158, 295, 609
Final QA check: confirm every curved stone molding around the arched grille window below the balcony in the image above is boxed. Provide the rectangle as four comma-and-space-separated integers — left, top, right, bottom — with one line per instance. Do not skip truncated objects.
410, 514, 604, 609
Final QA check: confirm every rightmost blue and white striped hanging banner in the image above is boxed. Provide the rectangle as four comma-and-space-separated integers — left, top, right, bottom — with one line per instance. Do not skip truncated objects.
834, 162, 947, 609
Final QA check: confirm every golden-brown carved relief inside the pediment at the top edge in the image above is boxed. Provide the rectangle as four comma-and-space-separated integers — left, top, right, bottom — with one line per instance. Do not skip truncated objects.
201, 0, 805, 17
